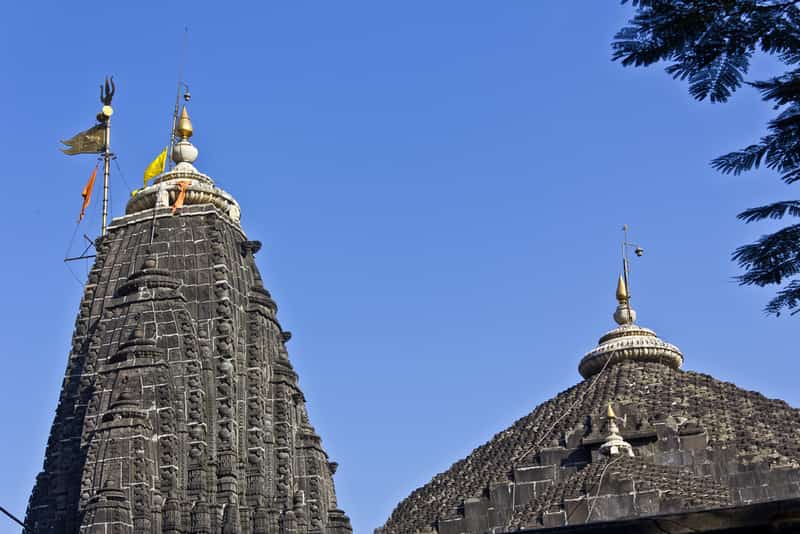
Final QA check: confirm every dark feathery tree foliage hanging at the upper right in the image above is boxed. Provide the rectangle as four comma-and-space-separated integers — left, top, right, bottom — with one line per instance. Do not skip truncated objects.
612, 0, 800, 315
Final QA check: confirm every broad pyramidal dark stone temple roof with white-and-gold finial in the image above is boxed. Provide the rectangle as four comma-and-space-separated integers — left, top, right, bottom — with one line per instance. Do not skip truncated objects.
376, 280, 800, 534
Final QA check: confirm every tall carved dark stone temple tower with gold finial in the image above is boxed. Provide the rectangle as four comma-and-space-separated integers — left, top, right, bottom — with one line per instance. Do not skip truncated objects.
26, 108, 352, 534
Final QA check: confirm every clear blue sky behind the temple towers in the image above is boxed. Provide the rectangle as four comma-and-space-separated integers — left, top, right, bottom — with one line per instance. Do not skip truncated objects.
0, 4, 800, 534
